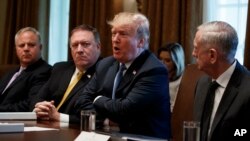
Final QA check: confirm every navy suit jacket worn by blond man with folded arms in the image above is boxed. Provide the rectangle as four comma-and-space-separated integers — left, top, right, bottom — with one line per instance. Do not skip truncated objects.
76, 51, 170, 138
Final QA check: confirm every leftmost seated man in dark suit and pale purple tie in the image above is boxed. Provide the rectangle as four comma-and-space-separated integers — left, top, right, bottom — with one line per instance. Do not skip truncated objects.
0, 27, 51, 112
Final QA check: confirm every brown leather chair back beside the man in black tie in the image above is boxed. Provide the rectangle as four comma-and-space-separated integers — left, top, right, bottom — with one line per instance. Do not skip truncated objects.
171, 64, 204, 141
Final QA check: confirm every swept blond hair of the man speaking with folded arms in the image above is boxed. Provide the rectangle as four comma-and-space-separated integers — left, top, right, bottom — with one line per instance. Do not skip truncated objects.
108, 12, 150, 49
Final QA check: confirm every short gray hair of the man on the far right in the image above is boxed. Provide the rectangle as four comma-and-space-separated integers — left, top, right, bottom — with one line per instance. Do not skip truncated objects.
197, 21, 238, 58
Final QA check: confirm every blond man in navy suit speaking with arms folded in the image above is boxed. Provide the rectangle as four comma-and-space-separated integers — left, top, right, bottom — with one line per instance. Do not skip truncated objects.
76, 12, 170, 138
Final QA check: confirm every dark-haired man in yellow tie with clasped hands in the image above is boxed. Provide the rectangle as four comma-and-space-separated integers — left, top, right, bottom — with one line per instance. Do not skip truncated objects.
31, 25, 101, 123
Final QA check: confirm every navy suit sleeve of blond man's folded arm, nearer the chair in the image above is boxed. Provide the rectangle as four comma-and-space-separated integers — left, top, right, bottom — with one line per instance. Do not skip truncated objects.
94, 68, 169, 122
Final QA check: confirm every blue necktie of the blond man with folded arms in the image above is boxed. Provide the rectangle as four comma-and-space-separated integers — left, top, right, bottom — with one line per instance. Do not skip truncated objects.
112, 64, 126, 99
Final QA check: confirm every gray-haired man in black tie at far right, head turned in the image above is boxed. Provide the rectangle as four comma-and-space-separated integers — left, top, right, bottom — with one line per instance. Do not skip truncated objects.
193, 21, 250, 141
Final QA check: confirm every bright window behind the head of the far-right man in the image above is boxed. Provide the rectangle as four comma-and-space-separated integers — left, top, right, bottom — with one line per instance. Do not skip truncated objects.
203, 0, 248, 64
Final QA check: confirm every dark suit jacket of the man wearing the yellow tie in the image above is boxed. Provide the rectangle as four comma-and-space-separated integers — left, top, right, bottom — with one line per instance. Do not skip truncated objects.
31, 61, 99, 123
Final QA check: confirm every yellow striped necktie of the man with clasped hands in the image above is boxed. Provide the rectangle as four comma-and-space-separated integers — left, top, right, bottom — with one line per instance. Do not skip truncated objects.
56, 72, 83, 110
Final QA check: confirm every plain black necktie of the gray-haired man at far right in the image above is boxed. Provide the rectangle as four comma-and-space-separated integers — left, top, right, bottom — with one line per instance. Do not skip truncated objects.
200, 81, 219, 141
